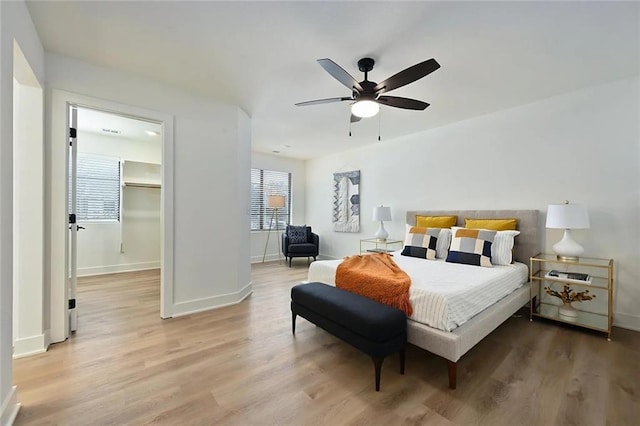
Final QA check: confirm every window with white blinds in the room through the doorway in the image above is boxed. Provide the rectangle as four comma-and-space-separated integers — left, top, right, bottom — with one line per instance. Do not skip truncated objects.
69, 153, 120, 221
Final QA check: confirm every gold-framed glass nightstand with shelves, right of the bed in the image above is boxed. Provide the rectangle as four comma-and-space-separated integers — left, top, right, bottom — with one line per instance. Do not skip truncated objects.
529, 254, 613, 341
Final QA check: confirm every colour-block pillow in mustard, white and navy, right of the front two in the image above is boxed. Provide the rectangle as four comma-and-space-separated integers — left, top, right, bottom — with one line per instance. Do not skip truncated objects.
447, 227, 497, 267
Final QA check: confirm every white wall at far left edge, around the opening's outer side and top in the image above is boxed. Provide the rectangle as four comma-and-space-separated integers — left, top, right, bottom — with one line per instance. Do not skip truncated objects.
0, 1, 44, 425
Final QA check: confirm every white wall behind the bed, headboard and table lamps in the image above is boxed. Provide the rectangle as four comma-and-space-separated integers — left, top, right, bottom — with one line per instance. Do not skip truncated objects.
306, 77, 640, 330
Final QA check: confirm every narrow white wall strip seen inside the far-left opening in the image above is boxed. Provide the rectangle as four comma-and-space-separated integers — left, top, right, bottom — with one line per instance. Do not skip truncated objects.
13, 77, 49, 357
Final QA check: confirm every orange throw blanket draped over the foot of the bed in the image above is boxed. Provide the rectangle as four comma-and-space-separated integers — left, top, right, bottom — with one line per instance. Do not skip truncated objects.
336, 253, 413, 316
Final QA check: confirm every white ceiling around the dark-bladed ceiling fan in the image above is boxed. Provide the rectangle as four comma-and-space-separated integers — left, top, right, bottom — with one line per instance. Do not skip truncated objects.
28, 1, 640, 158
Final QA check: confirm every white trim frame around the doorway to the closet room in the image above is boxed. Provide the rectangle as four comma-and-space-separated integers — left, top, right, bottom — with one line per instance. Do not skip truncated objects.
47, 89, 175, 342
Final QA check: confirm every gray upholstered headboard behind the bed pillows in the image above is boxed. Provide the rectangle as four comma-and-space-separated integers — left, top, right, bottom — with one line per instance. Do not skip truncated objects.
407, 210, 540, 266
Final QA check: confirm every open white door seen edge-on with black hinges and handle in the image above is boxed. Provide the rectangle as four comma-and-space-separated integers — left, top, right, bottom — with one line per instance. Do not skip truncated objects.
67, 105, 83, 334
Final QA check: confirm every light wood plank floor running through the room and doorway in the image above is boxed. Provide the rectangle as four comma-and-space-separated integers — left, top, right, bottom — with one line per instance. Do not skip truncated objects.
14, 261, 640, 425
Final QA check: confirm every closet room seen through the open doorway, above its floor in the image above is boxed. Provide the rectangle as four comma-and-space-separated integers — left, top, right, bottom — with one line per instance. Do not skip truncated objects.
68, 105, 163, 331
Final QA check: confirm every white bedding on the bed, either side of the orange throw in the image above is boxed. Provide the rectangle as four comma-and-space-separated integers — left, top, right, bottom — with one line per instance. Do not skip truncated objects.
308, 251, 528, 331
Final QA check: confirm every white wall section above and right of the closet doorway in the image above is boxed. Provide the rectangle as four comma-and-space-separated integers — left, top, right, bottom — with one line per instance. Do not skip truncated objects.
46, 54, 251, 322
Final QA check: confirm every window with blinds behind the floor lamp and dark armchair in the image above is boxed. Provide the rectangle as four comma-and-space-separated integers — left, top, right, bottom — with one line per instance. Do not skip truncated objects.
251, 169, 291, 231
